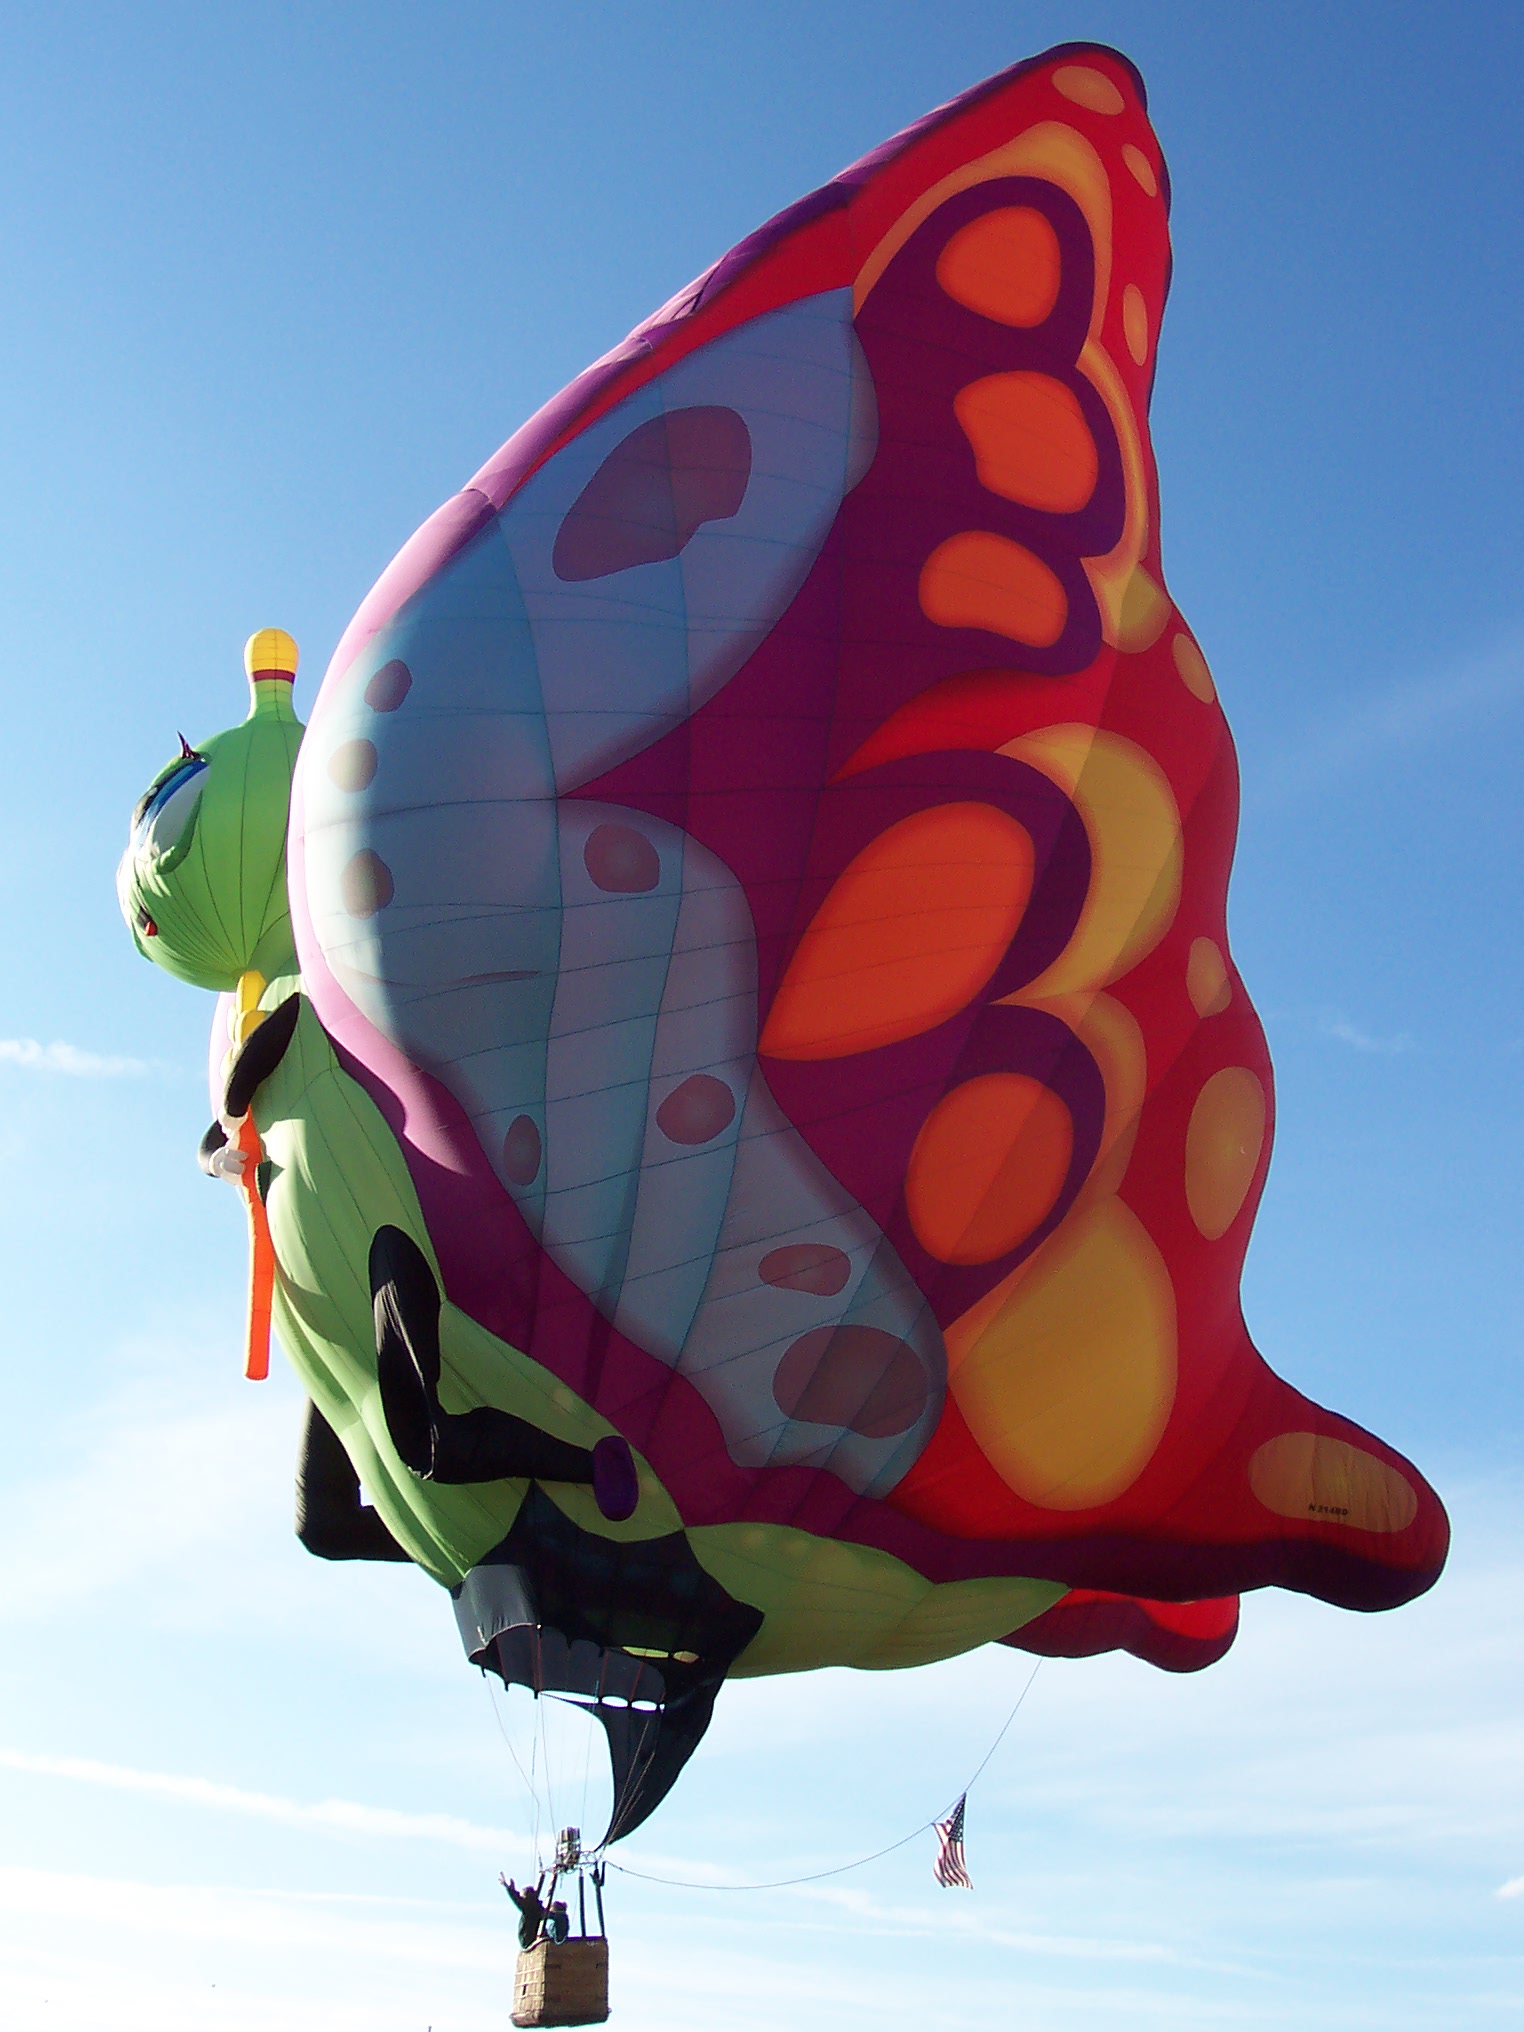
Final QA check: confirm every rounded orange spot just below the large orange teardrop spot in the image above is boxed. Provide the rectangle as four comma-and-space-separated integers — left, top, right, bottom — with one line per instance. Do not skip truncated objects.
904, 1073, 1075, 1264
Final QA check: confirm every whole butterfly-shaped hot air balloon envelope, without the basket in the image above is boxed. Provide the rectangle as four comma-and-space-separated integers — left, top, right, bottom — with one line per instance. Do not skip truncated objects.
120, 47, 1447, 1839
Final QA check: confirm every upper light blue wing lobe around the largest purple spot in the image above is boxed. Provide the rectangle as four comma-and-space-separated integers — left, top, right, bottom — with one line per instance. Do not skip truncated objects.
500, 291, 876, 790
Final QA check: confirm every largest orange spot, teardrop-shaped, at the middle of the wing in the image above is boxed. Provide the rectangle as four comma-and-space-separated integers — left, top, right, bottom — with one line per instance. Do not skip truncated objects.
760, 803, 1032, 1059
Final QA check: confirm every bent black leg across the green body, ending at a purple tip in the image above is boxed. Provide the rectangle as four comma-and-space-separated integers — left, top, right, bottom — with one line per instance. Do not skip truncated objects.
370, 1227, 593, 1483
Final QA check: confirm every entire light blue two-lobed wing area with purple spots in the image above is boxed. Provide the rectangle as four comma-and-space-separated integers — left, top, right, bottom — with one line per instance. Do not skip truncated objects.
301, 291, 945, 1489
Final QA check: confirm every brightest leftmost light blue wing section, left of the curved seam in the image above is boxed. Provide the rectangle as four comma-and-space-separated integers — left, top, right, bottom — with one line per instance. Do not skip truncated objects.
299, 528, 561, 1178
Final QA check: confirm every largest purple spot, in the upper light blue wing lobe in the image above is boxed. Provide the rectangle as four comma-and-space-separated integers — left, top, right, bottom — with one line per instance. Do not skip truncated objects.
551, 404, 752, 581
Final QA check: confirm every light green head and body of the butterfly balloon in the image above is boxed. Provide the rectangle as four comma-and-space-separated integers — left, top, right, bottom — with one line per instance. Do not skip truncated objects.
118, 679, 1065, 1676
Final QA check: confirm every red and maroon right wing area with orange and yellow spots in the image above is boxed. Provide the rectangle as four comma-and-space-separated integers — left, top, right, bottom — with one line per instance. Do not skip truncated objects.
577, 53, 1447, 1622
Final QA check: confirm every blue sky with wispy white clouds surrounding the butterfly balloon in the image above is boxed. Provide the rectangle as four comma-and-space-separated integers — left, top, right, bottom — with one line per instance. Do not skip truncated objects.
0, 0, 1524, 2032
